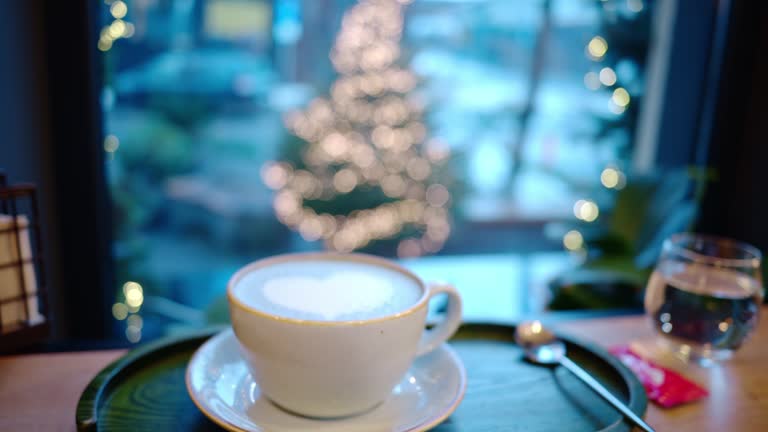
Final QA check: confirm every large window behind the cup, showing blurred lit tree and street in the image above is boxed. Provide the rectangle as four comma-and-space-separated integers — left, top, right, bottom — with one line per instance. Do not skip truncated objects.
94, 0, 653, 342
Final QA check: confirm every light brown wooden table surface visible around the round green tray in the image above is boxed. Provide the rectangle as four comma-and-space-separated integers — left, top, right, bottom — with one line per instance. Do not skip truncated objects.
0, 310, 768, 432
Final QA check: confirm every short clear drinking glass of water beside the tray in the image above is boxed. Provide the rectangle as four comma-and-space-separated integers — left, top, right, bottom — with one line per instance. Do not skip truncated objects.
645, 233, 763, 365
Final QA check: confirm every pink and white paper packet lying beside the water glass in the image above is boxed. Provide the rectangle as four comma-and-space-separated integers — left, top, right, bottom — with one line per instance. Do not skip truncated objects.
609, 345, 709, 408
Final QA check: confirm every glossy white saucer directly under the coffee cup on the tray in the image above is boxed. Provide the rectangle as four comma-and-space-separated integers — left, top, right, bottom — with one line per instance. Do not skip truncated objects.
186, 329, 467, 432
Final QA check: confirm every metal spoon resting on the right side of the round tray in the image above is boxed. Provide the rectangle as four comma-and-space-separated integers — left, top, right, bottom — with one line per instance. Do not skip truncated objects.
515, 321, 654, 432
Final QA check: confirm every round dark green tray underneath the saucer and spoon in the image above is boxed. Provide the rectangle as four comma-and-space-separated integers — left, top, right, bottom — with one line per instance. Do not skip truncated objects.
76, 324, 647, 432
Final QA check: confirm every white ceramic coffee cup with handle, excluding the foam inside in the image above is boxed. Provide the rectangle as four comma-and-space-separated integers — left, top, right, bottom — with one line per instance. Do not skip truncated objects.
227, 253, 461, 417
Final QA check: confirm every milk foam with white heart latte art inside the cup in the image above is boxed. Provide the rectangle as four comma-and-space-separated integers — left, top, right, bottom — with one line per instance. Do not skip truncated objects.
233, 261, 422, 321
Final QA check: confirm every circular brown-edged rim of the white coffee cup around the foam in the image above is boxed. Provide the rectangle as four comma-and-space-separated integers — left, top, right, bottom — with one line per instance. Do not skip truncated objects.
227, 252, 429, 327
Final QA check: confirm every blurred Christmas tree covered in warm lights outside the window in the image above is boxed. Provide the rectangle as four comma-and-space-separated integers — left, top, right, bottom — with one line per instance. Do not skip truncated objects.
262, 0, 451, 256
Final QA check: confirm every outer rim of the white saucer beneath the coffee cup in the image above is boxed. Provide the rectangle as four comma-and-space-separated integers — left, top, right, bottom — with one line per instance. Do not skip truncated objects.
184, 328, 467, 432
